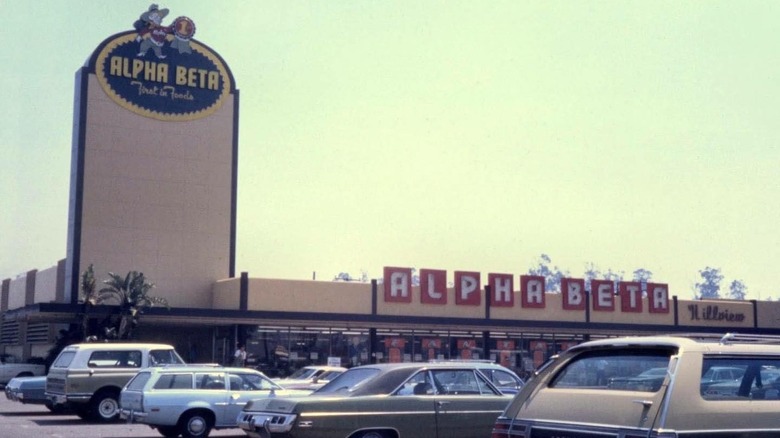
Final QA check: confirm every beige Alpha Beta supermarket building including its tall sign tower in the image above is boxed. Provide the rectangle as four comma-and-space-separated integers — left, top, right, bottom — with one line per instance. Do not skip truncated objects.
0, 10, 780, 372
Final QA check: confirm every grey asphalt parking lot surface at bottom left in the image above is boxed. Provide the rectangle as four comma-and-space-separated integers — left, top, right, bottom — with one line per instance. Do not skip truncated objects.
0, 394, 246, 438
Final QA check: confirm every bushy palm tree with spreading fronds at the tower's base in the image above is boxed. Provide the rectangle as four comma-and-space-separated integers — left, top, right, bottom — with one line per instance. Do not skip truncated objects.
98, 271, 168, 339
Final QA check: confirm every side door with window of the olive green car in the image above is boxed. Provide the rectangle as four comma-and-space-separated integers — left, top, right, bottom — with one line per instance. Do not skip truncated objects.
431, 368, 512, 438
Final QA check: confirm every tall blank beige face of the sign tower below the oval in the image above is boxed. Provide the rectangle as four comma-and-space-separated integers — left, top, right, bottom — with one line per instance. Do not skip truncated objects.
78, 75, 233, 307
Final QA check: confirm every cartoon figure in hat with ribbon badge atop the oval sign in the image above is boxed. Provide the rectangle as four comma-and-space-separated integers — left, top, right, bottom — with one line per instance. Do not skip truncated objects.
133, 4, 195, 59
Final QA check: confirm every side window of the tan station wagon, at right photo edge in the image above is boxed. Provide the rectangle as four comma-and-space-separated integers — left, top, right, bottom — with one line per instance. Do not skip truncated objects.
700, 357, 780, 402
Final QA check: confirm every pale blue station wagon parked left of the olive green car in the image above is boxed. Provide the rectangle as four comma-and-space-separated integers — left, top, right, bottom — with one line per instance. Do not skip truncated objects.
120, 365, 311, 438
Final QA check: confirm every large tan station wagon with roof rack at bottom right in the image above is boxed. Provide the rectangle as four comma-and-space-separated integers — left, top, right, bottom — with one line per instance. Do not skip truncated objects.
491, 334, 780, 438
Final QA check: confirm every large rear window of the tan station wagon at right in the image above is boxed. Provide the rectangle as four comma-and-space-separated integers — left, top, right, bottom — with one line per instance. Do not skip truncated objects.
550, 348, 675, 392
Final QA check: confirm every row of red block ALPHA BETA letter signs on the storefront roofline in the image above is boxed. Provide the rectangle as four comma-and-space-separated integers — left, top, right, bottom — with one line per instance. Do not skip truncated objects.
384, 267, 669, 313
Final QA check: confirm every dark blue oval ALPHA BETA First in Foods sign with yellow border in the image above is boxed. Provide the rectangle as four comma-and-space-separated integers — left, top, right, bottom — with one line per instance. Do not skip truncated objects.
95, 28, 232, 121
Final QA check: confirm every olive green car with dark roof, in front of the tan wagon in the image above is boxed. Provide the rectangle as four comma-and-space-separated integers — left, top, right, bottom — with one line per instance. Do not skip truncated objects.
237, 362, 512, 438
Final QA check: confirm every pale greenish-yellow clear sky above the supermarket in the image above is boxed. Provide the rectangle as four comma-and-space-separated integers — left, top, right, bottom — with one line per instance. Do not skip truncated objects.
0, 0, 780, 299
